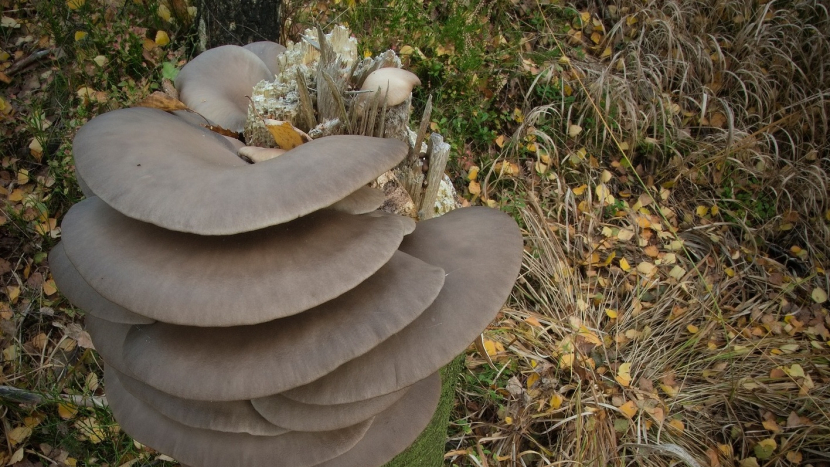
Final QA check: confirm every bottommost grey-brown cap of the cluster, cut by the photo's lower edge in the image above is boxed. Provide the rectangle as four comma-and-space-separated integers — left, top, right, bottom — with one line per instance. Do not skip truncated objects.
104, 369, 371, 467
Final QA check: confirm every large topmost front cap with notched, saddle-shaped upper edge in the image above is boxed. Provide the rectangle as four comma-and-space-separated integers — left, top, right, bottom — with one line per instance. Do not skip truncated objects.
74, 108, 408, 235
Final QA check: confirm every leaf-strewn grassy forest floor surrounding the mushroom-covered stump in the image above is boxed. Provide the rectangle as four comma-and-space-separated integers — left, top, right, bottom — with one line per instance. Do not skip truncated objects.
0, 0, 830, 467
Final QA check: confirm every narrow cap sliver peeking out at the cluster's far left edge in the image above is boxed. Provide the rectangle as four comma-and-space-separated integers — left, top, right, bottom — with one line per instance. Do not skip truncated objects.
49, 243, 156, 324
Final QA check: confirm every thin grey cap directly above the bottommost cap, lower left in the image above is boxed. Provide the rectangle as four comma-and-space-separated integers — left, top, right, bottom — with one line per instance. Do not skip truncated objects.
114, 367, 290, 436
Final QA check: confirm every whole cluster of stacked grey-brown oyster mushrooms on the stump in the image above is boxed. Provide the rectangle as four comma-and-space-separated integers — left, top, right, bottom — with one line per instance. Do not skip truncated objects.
49, 39, 522, 467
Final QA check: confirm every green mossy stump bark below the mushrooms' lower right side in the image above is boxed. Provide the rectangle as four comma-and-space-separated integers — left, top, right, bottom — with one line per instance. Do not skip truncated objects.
383, 354, 464, 467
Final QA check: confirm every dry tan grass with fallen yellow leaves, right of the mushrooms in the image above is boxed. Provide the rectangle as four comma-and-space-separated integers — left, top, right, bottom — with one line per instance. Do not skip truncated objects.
456, 0, 830, 467
